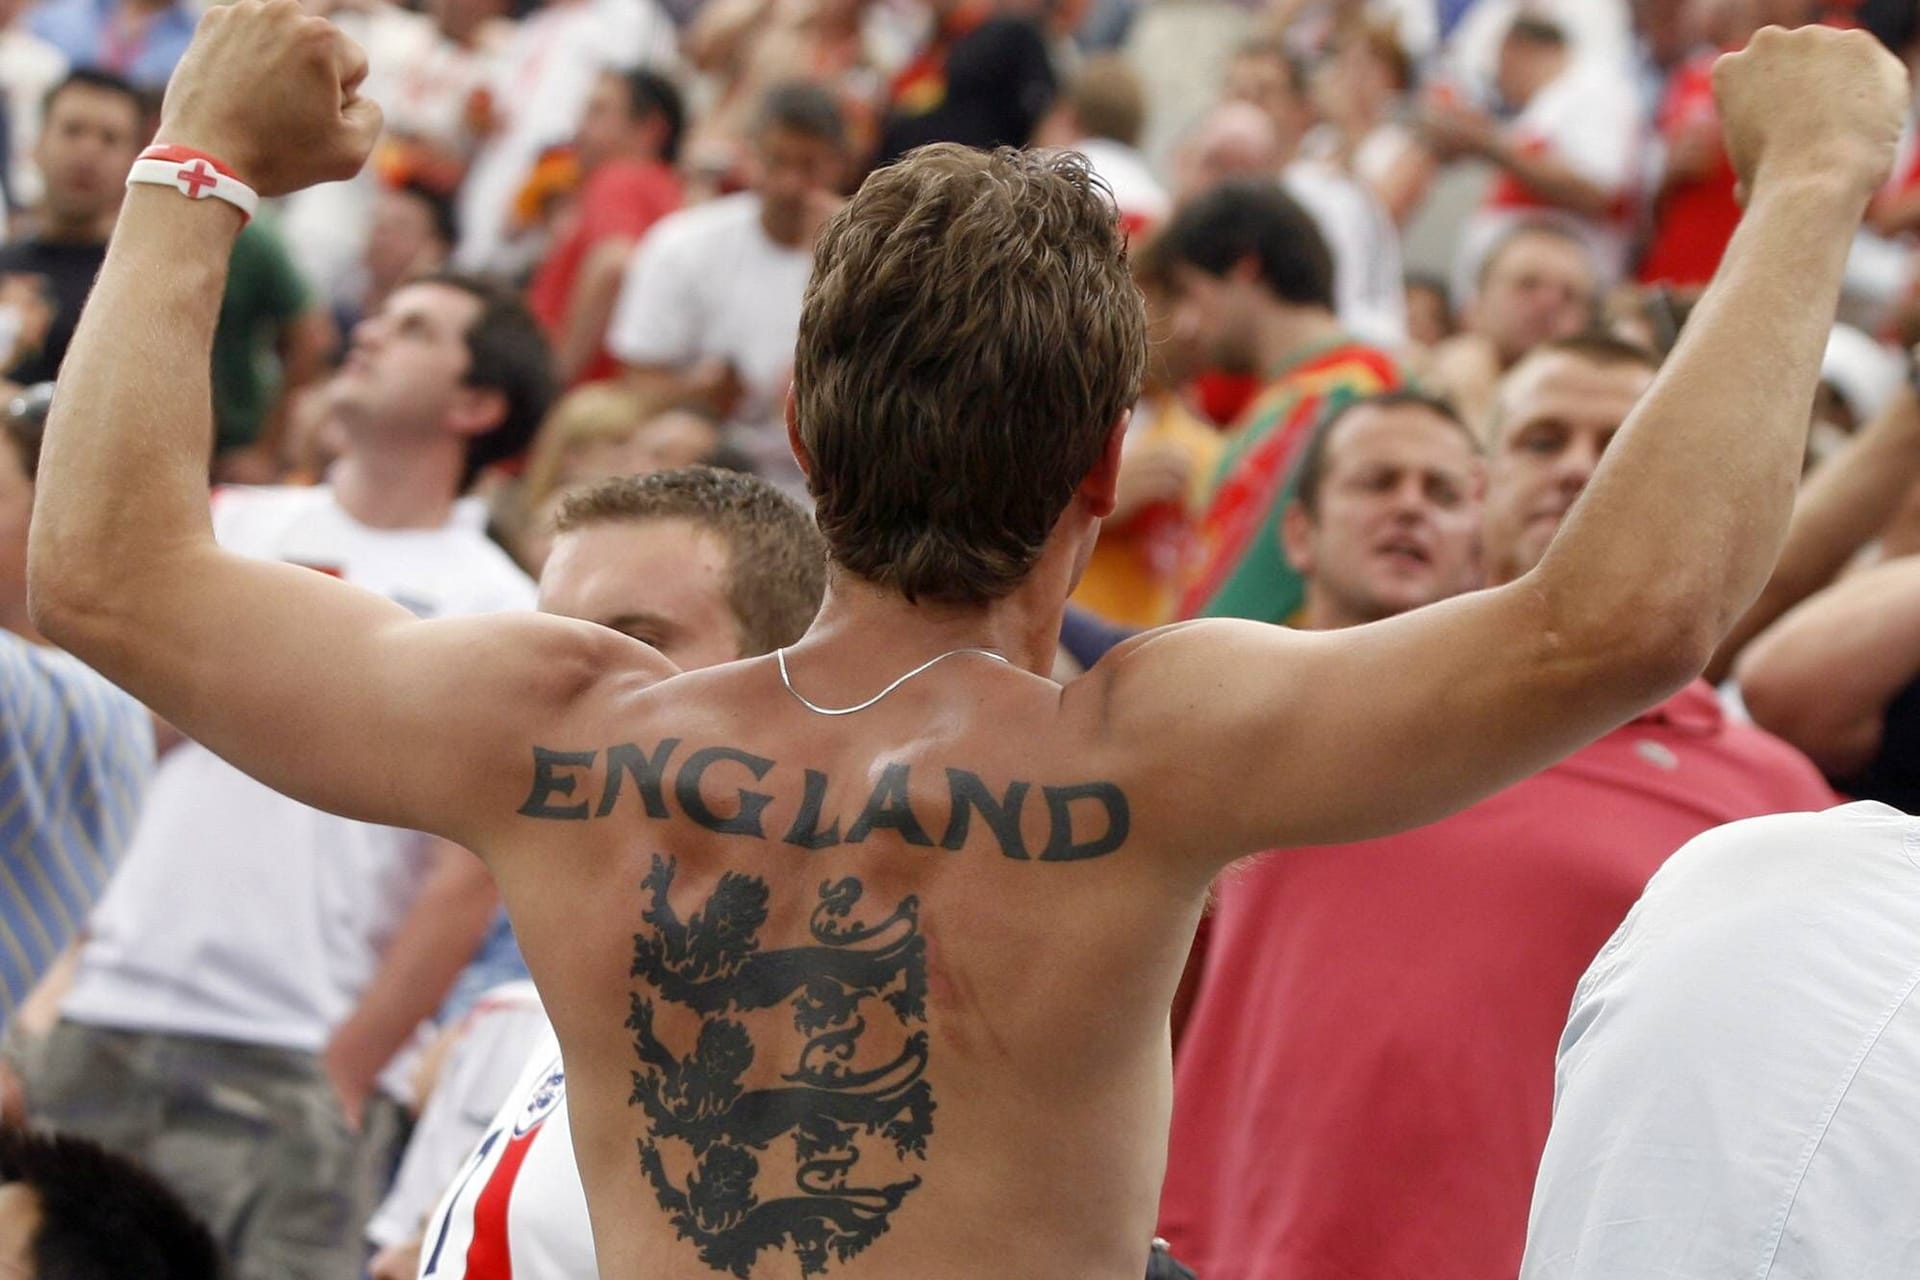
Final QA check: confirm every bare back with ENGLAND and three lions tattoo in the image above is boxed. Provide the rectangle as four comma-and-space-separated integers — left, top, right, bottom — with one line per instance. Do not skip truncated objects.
497, 656, 1204, 1280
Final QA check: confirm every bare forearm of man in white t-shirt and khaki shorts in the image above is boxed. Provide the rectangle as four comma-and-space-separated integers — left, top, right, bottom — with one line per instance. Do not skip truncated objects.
323, 841, 499, 1125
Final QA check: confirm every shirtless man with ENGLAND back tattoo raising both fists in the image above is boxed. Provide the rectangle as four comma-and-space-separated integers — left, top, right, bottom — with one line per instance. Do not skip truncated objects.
31, 0, 1908, 1280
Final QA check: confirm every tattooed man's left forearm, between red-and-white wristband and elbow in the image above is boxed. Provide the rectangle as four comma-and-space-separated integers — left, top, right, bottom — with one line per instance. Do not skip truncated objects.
29, 186, 240, 637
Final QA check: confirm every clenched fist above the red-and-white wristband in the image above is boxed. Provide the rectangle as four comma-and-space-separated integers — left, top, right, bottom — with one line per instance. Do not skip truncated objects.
157, 0, 380, 196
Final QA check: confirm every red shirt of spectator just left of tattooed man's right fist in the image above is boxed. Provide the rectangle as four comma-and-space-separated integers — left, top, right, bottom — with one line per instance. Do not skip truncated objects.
1640, 54, 1740, 286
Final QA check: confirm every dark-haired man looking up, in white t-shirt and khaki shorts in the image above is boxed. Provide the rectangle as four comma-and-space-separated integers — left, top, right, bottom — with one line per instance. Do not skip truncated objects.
27, 276, 551, 1280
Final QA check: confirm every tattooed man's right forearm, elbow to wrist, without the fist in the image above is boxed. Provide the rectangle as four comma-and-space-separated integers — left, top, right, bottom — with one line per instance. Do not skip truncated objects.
1536, 177, 1866, 670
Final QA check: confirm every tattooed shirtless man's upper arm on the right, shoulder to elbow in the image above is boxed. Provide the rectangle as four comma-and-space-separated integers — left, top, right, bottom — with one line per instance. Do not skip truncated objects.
1112, 583, 1670, 864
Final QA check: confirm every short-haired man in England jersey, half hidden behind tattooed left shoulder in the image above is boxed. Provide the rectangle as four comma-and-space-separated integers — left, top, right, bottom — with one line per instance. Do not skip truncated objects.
369, 466, 826, 1280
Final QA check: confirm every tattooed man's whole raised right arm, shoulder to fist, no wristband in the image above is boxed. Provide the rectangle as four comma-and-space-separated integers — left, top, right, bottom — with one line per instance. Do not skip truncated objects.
1091, 29, 1907, 869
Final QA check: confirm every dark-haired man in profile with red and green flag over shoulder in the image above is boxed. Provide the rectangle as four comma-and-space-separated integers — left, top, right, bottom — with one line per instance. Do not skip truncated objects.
1164, 178, 1402, 622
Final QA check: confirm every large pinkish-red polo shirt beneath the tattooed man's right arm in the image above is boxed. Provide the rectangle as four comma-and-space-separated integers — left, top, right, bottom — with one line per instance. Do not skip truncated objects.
1160, 681, 1834, 1280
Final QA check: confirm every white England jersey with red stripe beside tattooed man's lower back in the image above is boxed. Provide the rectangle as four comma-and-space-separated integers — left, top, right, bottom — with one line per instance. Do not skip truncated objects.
420, 1032, 599, 1280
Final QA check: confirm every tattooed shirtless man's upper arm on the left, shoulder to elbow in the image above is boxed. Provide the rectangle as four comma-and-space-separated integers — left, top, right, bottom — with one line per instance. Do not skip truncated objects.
56, 547, 657, 848
